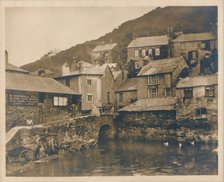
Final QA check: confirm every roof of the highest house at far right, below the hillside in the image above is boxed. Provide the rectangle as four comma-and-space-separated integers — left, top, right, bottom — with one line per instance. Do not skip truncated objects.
173, 32, 215, 42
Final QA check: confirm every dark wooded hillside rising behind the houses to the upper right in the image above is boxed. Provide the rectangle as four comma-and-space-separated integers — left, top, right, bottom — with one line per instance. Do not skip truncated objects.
22, 7, 217, 76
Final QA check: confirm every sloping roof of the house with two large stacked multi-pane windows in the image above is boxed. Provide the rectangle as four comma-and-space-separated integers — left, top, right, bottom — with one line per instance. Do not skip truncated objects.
138, 57, 187, 76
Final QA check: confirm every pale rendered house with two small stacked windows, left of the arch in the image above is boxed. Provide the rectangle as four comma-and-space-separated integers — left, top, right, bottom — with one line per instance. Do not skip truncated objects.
55, 64, 115, 114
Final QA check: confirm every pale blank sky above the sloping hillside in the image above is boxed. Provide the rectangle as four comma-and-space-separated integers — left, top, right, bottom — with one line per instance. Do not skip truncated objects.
5, 6, 155, 66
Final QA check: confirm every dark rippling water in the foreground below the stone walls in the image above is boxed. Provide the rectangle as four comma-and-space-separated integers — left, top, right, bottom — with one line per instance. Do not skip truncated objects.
15, 141, 218, 176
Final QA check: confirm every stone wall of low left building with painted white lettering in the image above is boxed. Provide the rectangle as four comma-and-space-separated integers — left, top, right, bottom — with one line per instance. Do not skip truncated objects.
6, 91, 79, 131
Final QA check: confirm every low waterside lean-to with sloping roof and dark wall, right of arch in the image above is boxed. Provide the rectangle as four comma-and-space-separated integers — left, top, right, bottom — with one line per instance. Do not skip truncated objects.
119, 97, 176, 126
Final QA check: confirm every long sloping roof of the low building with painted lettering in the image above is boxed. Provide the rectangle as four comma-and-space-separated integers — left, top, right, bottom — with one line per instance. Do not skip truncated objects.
6, 72, 80, 95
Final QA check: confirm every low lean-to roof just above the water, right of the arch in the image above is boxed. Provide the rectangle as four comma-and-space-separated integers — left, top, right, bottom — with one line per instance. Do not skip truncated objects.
119, 97, 176, 112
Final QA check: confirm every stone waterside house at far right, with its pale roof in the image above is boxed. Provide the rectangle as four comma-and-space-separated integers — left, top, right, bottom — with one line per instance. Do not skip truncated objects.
176, 74, 218, 125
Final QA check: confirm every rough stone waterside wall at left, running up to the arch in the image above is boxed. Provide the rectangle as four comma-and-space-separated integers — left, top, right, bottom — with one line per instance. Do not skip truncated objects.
6, 115, 115, 162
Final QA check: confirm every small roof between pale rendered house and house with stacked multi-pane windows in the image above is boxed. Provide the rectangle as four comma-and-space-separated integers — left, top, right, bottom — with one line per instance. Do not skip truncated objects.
116, 78, 138, 92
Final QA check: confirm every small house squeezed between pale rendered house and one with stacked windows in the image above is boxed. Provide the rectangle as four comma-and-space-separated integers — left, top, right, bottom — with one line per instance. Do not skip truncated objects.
115, 78, 138, 109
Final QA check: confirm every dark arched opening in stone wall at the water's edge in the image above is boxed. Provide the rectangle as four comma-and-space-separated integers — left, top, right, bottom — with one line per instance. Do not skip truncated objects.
98, 125, 114, 142
